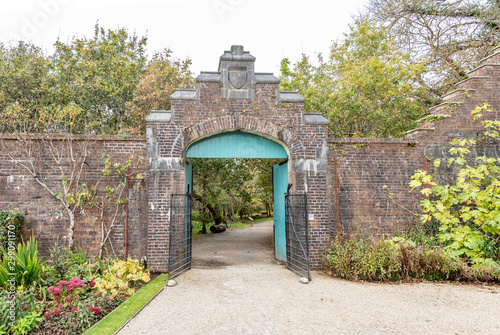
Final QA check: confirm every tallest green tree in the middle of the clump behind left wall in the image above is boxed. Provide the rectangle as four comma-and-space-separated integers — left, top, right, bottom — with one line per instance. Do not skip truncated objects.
50, 25, 147, 134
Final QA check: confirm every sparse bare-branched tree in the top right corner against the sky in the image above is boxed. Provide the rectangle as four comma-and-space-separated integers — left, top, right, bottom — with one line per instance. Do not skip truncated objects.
363, 0, 500, 103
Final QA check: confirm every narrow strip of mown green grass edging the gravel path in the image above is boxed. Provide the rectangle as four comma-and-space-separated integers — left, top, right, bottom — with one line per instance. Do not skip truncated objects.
83, 274, 168, 335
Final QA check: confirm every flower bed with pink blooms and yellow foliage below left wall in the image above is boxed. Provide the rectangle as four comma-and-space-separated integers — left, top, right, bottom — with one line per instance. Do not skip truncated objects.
0, 240, 150, 335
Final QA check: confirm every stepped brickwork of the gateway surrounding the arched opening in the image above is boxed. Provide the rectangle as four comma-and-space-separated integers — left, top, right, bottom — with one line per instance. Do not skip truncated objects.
147, 82, 331, 271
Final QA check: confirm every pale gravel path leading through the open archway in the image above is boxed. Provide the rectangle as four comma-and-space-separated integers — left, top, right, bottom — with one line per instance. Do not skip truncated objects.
119, 222, 500, 335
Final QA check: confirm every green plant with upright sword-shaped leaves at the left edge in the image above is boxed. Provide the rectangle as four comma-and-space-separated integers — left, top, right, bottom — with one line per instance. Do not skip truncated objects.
0, 239, 43, 287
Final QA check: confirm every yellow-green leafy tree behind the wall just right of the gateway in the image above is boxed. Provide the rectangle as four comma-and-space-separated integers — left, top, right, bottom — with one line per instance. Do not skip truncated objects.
281, 19, 426, 137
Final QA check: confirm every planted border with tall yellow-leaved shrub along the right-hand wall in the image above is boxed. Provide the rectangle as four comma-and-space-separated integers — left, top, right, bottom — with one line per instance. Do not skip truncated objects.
324, 104, 500, 282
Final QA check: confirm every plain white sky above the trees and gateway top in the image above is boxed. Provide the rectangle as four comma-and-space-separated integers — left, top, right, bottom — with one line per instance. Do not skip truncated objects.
0, 0, 368, 75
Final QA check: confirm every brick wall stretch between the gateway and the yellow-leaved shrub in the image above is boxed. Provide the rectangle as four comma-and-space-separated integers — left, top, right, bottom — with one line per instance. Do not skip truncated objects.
327, 138, 424, 236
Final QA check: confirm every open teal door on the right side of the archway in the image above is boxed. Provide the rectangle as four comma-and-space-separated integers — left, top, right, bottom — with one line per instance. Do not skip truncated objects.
273, 162, 288, 262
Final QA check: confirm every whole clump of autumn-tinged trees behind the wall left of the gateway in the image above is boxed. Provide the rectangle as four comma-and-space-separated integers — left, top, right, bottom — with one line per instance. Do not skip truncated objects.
0, 25, 194, 134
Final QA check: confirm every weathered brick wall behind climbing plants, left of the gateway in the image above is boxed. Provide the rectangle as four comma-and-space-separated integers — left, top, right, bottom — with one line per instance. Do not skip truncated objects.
0, 135, 148, 259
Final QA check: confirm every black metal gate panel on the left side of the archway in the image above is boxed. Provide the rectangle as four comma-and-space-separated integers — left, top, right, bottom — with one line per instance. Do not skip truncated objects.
168, 194, 192, 278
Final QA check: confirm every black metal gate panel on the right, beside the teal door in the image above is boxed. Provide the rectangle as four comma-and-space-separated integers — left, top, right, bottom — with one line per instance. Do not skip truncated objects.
285, 193, 311, 280
